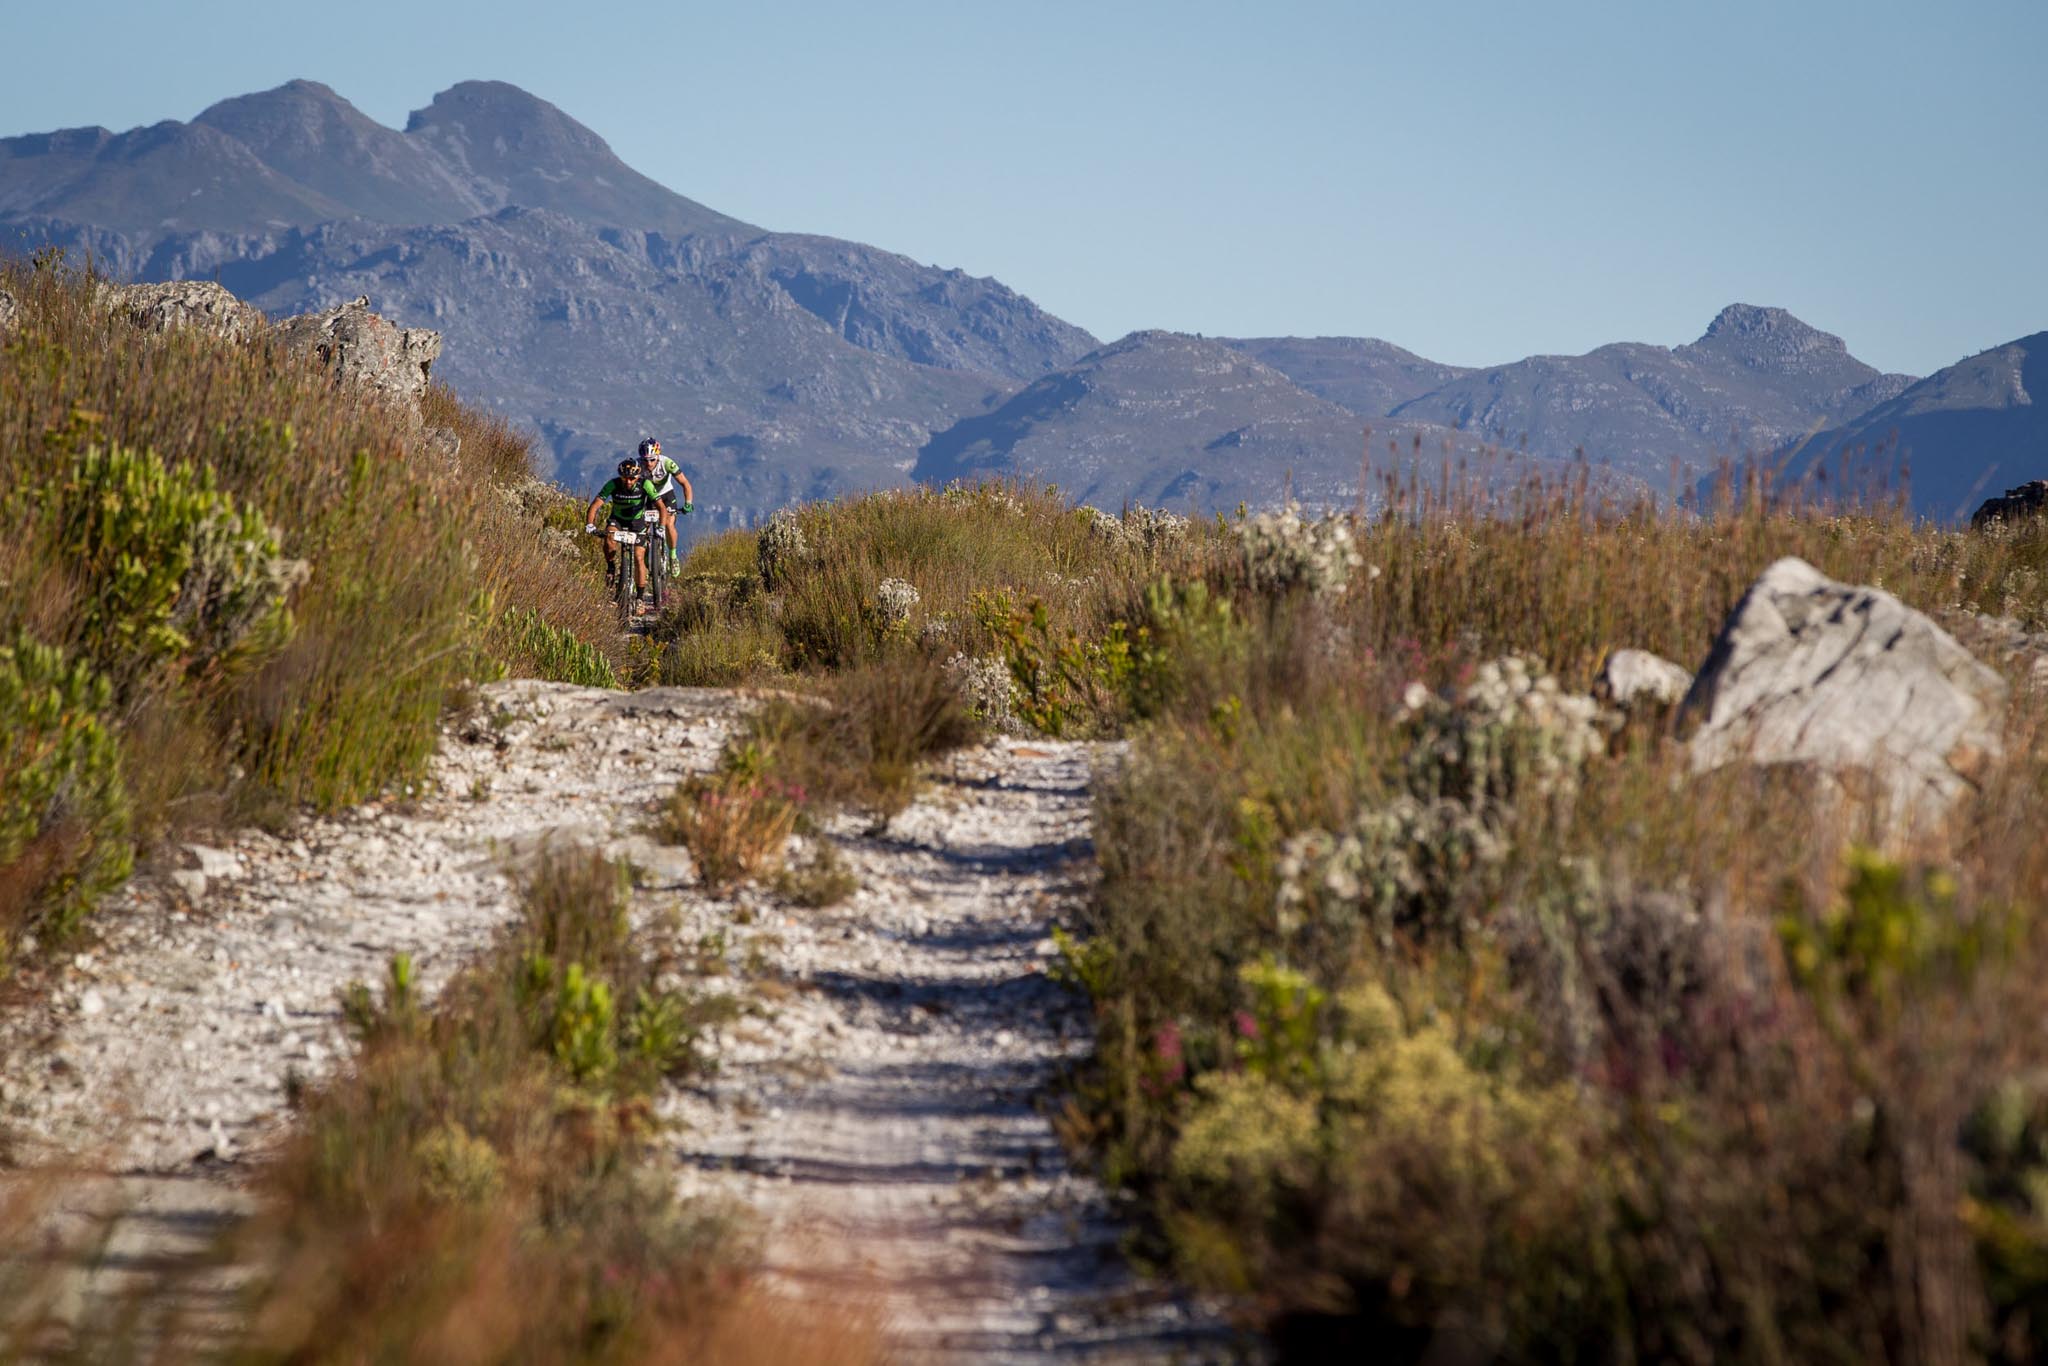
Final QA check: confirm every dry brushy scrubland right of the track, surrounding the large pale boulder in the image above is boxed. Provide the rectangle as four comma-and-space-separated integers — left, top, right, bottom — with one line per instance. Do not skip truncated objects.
662, 466, 2048, 1362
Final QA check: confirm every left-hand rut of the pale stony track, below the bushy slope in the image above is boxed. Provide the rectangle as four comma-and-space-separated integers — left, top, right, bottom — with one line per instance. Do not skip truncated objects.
0, 682, 743, 1173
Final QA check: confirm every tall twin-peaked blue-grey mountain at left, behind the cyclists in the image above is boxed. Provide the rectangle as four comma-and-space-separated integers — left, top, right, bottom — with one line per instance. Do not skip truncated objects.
0, 80, 1096, 520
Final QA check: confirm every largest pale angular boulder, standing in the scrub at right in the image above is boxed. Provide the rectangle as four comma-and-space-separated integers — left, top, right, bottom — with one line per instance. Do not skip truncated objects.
1683, 559, 2005, 821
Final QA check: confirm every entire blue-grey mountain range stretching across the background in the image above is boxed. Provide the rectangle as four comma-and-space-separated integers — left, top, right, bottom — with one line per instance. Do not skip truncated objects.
0, 80, 2048, 524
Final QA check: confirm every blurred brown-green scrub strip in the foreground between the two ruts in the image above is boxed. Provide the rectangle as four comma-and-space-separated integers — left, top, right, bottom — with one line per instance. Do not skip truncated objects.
221, 850, 748, 1360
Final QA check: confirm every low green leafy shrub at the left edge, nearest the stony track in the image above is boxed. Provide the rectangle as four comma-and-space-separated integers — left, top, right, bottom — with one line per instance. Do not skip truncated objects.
0, 641, 133, 963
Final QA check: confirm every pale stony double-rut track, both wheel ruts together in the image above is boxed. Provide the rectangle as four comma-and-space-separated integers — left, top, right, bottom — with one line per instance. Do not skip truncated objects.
0, 682, 1225, 1360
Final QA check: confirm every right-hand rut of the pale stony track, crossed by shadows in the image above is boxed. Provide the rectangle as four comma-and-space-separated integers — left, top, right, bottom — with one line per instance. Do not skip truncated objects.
672, 741, 1229, 1362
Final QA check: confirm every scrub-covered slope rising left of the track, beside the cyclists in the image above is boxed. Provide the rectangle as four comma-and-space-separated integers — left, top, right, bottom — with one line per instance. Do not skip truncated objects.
0, 260, 614, 954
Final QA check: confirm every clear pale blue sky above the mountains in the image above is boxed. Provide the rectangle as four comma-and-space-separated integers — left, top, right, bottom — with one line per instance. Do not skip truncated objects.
0, 0, 2048, 373
